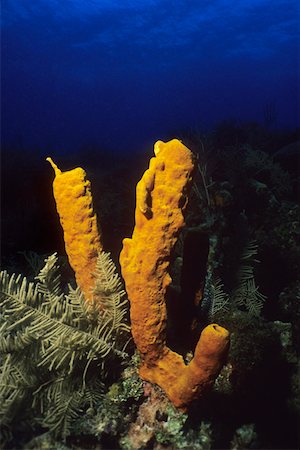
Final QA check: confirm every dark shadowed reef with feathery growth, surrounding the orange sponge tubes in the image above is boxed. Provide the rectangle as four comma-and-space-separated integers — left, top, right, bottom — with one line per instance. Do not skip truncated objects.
0, 121, 300, 450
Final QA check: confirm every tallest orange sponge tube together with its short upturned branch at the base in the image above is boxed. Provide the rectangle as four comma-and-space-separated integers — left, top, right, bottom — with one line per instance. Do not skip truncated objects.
120, 139, 229, 410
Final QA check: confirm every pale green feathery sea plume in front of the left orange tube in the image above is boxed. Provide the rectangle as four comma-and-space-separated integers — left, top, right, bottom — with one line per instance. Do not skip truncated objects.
0, 252, 130, 438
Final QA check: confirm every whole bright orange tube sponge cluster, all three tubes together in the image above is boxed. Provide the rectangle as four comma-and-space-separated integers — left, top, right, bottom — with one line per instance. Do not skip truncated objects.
47, 139, 229, 410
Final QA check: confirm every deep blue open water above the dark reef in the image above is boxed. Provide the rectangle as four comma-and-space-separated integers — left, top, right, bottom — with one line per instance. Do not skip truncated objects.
1, 0, 299, 151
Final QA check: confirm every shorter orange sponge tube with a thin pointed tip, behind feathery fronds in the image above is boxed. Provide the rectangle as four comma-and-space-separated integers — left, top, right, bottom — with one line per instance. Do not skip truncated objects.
47, 158, 102, 301
